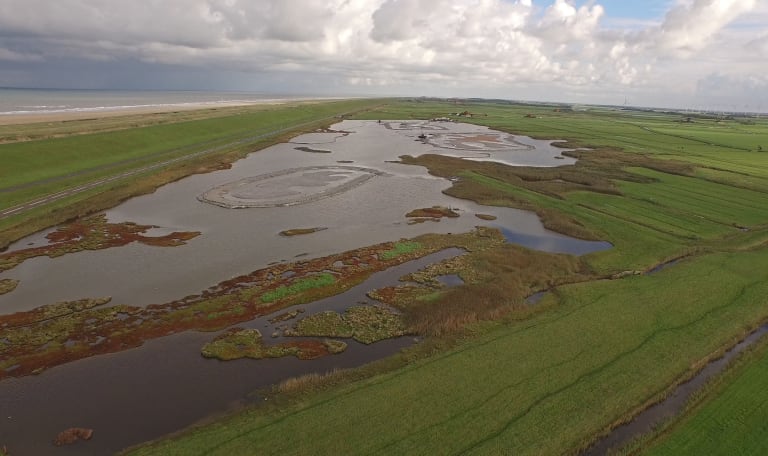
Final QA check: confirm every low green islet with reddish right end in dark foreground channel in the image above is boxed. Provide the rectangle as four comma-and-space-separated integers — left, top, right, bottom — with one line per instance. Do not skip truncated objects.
201, 329, 347, 361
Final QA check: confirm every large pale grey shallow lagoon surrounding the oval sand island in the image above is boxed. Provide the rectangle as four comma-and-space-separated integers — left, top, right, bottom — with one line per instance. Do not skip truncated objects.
0, 121, 592, 314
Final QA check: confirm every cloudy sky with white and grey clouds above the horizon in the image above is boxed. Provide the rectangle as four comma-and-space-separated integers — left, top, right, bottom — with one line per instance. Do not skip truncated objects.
0, 0, 768, 111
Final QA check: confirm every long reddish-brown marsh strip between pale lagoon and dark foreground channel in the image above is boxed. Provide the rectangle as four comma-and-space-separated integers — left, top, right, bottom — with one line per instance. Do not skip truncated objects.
0, 228, 503, 379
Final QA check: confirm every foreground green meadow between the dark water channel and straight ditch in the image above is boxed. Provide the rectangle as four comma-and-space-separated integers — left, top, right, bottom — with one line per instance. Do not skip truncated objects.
136, 249, 768, 455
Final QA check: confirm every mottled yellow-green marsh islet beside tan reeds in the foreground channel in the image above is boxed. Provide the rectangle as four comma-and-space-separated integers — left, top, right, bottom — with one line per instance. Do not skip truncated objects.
286, 306, 406, 344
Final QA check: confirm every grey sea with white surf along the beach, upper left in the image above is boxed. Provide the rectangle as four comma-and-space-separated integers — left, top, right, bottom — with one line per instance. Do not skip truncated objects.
0, 88, 323, 116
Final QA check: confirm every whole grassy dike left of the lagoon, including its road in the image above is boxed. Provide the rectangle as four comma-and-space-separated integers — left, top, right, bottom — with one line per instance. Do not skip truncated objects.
0, 100, 380, 246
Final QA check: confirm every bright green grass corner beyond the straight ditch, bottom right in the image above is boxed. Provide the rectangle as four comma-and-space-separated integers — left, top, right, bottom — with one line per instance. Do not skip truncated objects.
643, 338, 768, 456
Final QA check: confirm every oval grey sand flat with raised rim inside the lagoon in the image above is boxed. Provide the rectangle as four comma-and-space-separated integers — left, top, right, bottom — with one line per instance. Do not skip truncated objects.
197, 166, 384, 209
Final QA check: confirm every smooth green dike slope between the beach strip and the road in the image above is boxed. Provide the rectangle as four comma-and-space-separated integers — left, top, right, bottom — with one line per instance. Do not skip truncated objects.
0, 101, 370, 193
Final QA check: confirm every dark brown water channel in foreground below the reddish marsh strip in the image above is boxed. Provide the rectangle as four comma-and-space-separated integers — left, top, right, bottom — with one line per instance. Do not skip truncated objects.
0, 249, 463, 456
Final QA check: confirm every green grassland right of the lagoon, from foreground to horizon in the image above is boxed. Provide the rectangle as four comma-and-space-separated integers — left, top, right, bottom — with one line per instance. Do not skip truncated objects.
126, 103, 768, 454
